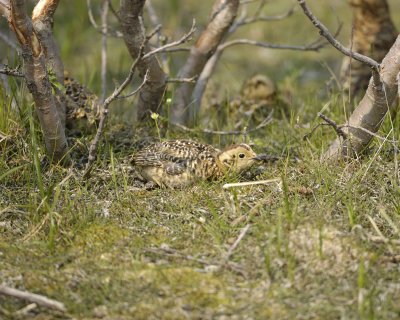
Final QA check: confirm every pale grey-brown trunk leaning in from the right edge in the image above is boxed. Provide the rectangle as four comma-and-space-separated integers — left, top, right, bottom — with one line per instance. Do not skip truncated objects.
323, 35, 400, 160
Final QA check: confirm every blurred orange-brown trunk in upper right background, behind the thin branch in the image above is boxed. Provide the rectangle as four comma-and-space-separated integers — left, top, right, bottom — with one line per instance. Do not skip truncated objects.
341, 0, 398, 98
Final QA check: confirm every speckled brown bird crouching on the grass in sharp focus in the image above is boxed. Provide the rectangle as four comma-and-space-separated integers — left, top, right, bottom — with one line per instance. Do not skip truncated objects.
132, 140, 263, 188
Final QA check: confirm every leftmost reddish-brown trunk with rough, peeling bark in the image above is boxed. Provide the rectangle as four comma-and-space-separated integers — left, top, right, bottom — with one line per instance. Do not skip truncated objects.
8, 0, 69, 163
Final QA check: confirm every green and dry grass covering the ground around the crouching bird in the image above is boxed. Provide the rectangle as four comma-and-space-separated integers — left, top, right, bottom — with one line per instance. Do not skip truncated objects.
0, 1, 400, 319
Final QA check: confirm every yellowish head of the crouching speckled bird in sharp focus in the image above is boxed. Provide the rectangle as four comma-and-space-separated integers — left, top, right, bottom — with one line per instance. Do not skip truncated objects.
218, 143, 259, 173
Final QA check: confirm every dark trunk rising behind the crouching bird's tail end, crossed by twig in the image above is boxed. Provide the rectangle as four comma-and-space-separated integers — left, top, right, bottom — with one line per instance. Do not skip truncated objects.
120, 0, 166, 120
